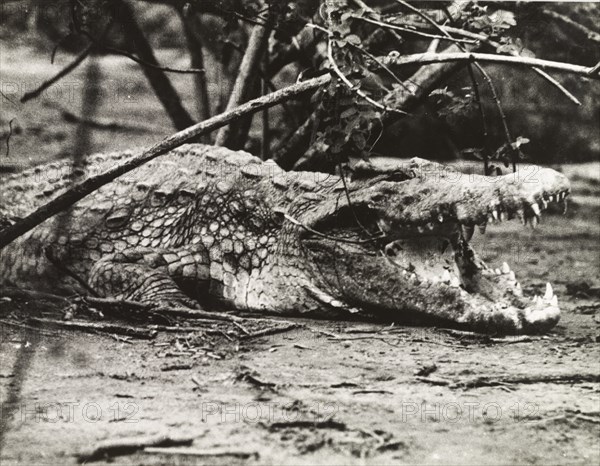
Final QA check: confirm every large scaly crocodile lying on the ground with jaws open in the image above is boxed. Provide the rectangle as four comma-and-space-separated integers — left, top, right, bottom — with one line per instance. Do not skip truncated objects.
0, 144, 570, 334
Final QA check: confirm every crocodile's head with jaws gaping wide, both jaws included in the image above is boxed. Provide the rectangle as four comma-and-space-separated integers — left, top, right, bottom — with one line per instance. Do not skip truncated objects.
301, 162, 570, 333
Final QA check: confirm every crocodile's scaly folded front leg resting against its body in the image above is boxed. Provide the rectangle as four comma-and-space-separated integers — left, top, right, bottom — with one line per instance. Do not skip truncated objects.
89, 248, 209, 308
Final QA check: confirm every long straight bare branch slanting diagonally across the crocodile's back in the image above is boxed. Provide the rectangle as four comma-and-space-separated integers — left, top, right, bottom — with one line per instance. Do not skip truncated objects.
0, 74, 331, 249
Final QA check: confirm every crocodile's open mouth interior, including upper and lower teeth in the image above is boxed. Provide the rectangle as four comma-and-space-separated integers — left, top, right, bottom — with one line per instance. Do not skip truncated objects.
380, 191, 568, 333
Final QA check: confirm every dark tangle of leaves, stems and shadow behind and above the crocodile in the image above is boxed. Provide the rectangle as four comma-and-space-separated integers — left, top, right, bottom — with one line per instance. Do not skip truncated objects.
1, 0, 600, 170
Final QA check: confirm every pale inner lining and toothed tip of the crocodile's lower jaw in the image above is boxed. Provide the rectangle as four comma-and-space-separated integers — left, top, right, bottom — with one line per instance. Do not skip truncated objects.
386, 234, 560, 333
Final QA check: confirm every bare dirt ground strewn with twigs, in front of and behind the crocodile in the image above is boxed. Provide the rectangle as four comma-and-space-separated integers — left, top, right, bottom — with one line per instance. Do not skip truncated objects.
0, 49, 600, 465
